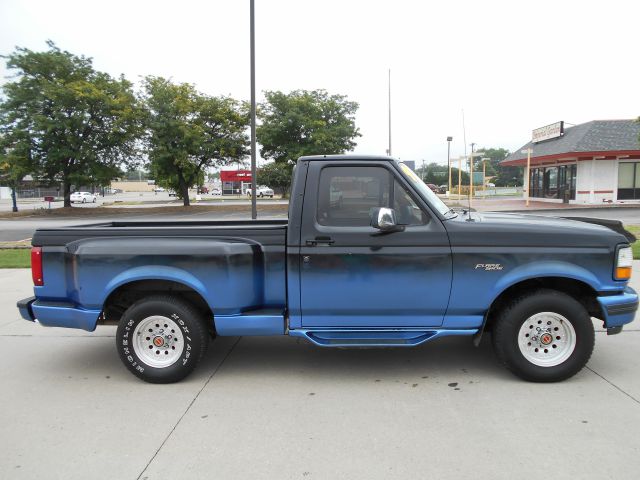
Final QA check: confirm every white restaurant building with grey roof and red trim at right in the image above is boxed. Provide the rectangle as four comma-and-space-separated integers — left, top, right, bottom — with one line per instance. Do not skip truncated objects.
501, 120, 640, 204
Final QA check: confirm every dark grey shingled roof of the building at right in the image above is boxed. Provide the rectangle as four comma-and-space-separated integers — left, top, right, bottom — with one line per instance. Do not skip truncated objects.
503, 120, 640, 162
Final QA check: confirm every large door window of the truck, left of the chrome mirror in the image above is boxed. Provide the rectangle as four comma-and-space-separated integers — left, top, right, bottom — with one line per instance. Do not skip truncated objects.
316, 167, 392, 227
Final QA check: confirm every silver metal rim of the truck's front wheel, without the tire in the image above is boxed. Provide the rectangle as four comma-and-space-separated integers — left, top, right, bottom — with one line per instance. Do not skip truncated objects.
518, 312, 576, 367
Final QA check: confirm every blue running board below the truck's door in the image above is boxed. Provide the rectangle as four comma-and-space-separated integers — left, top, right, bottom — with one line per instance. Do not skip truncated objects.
289, 328, 478, 347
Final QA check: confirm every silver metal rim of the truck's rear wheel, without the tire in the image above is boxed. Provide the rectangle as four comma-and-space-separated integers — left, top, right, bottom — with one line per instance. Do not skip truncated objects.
133, 315, 184, 368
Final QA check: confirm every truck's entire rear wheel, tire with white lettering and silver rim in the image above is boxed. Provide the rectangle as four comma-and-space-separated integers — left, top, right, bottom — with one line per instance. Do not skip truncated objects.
116, 295, 209, 383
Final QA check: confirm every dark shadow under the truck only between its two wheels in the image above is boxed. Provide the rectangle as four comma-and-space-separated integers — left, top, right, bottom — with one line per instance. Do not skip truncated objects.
205, 336, 519, 382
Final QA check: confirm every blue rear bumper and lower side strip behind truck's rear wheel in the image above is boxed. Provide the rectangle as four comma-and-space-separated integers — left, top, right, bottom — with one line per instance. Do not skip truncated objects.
18, 297, 100, 332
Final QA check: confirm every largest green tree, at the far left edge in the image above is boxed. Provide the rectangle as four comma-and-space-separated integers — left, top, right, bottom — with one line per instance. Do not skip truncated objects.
0, 41, 141, 207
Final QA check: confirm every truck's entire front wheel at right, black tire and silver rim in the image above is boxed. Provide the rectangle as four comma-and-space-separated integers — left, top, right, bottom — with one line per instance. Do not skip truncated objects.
492, 289, 595, 382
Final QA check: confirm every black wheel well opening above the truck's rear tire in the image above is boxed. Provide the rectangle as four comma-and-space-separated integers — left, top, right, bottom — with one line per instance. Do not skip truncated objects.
98, 280, 214, 330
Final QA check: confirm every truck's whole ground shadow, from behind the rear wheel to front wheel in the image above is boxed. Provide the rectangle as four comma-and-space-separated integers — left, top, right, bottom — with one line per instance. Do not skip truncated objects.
45, 336, 518, 383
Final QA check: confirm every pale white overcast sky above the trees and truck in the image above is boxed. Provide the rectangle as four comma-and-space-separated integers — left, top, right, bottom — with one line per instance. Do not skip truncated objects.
0, 0, 640, 164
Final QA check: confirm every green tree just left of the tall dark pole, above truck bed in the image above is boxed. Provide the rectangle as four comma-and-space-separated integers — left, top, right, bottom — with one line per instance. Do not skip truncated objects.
144, 77, 249, 206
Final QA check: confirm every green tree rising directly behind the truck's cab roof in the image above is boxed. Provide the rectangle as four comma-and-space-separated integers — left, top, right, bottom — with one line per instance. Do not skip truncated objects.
256, 90, 361, 188
